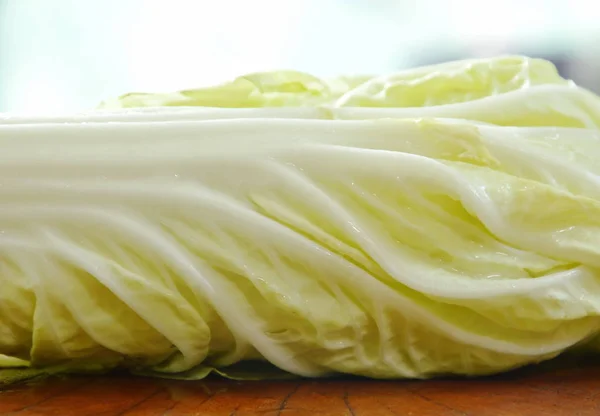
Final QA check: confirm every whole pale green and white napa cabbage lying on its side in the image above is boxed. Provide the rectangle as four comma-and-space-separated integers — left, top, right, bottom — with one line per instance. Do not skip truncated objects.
0, 57, 600, 382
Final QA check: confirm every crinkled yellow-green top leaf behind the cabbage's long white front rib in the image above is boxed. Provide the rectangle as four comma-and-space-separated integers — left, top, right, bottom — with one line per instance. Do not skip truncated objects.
100, 56, 600, 128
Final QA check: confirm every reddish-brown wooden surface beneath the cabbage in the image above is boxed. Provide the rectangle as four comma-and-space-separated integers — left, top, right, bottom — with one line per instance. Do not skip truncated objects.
0, 364, 600, 416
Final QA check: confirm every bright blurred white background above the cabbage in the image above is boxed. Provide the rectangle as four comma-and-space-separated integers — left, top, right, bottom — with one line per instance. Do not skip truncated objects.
0, 0, 600, 112
